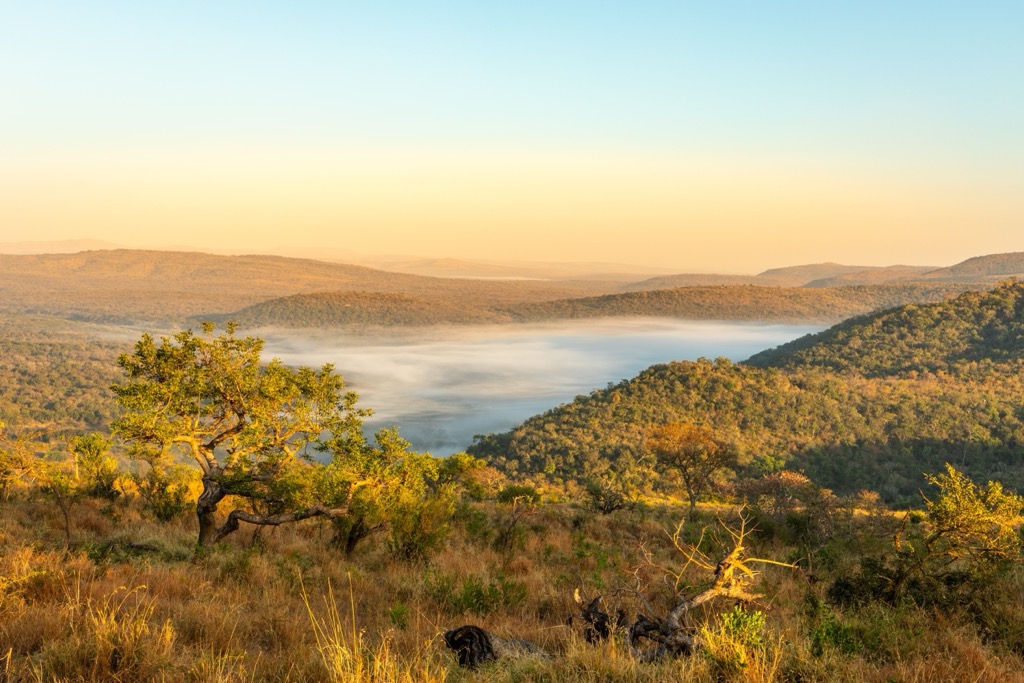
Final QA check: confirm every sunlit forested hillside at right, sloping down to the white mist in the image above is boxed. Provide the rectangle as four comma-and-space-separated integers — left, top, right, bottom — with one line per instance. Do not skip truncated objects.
470, 283, 1024, 503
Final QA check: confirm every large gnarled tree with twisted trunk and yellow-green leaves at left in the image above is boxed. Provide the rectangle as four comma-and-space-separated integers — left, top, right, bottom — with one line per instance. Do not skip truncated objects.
112, 324, 369, 547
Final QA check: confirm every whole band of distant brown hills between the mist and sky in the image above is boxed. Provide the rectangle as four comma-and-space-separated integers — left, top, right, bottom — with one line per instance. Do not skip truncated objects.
0, 249, 1024, 326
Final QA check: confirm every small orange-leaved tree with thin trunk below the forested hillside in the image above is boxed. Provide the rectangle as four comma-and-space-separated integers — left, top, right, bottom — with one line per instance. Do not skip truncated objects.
646, 422, 736, 520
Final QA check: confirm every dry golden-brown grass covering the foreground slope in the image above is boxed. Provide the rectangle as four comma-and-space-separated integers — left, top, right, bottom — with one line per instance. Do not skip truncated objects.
0, 500, 1024, 683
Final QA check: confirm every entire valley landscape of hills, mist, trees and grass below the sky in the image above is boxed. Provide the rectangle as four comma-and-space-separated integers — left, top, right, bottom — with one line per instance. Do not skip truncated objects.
0, 252, 1024, 683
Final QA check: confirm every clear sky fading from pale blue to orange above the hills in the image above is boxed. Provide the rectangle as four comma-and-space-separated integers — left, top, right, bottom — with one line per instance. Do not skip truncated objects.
0, 0, 1024, 272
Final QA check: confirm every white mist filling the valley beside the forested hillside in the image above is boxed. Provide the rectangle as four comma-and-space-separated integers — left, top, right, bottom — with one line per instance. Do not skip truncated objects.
259, 318, 821, 456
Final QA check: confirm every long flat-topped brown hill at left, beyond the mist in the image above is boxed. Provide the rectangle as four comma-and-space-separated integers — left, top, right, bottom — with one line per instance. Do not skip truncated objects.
0, 250, 618, 323
